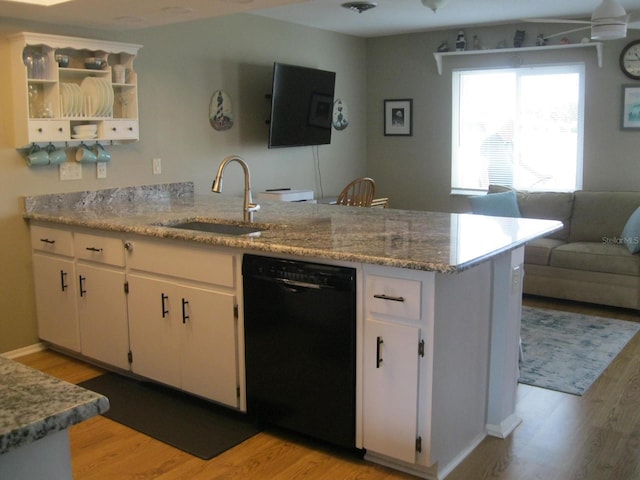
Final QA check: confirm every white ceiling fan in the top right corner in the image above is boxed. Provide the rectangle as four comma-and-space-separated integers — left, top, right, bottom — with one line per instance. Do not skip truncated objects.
524, 0, 640, 40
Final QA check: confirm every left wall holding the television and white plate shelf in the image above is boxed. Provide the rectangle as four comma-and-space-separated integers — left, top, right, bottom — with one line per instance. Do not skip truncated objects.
0, 14, 366, 352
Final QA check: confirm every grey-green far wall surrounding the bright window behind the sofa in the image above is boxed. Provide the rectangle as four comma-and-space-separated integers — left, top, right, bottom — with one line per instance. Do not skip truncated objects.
367, 24, 640, 211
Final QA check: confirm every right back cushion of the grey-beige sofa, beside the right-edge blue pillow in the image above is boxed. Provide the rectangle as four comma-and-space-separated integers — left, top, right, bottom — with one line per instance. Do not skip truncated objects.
569, 190, 640, 243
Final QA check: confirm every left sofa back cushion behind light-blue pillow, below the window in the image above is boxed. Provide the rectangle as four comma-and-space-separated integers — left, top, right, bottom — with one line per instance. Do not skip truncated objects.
489, 185, 573, 241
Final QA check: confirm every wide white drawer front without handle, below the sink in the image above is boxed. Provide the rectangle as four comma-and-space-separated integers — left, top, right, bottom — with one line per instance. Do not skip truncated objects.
127, 240, 235, 287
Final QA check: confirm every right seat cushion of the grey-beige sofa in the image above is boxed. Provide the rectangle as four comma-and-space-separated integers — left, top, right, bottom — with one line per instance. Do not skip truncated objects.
549, 242, 640, 275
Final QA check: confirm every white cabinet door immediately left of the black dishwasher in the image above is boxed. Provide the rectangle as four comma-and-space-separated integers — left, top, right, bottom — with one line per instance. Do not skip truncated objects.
179, 287, 238, 407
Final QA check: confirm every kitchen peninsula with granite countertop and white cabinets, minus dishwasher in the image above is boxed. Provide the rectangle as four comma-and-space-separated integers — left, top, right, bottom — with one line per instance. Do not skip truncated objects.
25, 182, 561, 478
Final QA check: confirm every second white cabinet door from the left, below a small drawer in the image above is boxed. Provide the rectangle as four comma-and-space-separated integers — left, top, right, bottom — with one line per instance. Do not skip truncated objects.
76, 264, 129, 369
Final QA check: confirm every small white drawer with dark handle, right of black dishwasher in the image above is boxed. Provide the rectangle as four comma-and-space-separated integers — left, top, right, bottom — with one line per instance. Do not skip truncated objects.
365, 275, 422, 320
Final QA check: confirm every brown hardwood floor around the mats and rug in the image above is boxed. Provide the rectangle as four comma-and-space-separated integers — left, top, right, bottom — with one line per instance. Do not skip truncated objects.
13, 297, 640, 480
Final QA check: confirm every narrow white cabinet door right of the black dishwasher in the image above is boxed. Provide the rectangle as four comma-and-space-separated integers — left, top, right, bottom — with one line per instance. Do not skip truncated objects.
363, 319, 420, 463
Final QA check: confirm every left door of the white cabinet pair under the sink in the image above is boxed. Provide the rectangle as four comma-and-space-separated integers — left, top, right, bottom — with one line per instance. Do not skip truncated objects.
128, 275, 180, 388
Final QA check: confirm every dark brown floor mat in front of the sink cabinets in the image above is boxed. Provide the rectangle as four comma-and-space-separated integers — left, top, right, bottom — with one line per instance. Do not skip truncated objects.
79, 373, 258, 460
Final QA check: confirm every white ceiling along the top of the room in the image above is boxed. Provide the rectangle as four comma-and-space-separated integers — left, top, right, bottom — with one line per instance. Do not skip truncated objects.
0, 0, 640, 37
